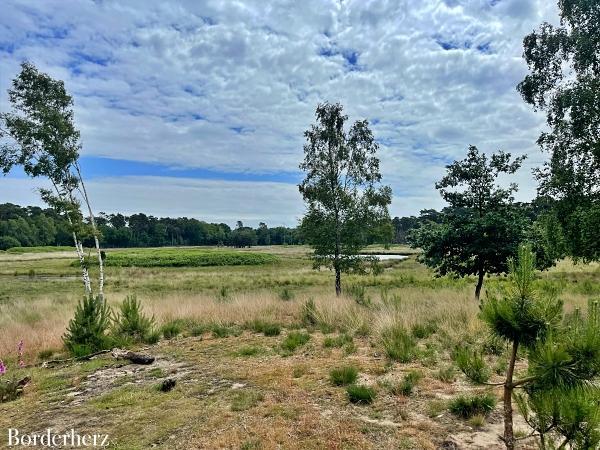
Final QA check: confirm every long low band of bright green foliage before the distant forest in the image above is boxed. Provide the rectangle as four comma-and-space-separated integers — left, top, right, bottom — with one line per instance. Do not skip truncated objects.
72, 249, 277, 267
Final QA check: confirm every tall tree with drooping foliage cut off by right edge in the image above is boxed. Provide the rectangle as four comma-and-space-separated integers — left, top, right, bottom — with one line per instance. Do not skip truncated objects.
517, 0, 600, 261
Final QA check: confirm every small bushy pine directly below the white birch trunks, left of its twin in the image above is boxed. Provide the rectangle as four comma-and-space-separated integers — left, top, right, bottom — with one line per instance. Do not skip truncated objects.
63, 295, 112, 356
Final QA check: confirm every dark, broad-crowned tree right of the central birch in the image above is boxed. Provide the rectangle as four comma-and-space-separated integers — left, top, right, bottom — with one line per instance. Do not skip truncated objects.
409, 146, 526, 299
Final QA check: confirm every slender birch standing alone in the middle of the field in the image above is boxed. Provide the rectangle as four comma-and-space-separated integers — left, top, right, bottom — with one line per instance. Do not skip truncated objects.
299, 103, 392, 295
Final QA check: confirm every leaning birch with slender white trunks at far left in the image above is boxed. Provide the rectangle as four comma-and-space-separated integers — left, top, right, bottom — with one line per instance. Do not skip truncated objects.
0, 62, 104, 298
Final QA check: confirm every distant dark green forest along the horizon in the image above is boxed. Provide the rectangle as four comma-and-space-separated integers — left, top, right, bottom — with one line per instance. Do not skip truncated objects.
0, 203, 548, 250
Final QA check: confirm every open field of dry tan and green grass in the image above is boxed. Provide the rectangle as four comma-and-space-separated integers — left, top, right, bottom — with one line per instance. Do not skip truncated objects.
0, 247, 600, 449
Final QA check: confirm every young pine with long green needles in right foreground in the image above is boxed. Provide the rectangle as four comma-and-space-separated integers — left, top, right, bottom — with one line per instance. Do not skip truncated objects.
467, 245, 600, 450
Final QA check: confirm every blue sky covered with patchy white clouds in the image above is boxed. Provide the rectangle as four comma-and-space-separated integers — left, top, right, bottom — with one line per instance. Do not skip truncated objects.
0, 0, 558, 226
